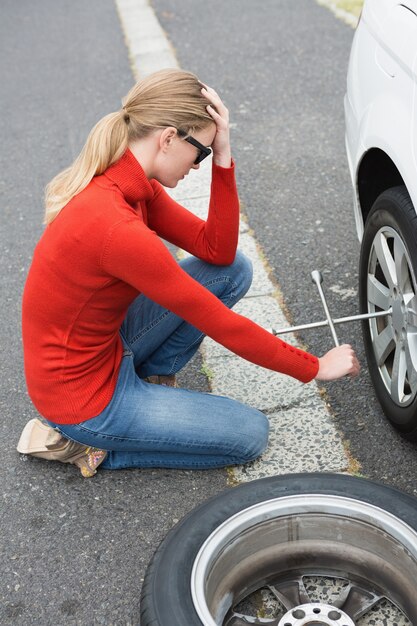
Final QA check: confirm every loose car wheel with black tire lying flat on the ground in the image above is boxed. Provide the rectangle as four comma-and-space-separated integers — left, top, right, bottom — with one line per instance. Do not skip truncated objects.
140, 473, 417, 626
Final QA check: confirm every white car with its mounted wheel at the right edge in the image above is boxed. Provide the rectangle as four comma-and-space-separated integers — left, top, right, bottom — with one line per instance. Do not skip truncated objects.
345, 0, 417, 439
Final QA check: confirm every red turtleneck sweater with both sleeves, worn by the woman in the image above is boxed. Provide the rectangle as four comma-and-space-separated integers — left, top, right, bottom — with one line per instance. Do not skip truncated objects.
23, 150, 318, 424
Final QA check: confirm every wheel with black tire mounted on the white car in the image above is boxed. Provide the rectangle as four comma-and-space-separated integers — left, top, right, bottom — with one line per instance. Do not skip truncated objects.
359, 186, 417, 440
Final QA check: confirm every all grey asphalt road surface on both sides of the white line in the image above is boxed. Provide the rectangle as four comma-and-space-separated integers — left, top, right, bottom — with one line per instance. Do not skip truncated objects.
0, 0, 416, 626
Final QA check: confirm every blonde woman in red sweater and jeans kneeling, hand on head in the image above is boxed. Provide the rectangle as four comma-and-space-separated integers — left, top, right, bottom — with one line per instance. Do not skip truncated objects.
18, 70, 359, 476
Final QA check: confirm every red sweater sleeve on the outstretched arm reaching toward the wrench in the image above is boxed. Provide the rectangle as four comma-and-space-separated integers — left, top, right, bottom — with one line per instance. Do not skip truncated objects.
101, 220, 318, 382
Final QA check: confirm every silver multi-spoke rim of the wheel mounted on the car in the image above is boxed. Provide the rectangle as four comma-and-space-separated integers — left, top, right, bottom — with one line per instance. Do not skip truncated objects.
367, 226, 417, 407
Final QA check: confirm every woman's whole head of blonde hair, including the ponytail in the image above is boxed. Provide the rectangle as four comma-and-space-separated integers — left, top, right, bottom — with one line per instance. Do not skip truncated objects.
44, 69, 213, 224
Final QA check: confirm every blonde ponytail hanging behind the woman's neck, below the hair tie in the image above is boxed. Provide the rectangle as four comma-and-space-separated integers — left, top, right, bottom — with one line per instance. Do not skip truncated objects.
44, 111, 129, 224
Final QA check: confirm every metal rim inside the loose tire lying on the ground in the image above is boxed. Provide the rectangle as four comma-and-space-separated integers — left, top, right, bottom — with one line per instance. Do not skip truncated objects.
191, 494, 417, 626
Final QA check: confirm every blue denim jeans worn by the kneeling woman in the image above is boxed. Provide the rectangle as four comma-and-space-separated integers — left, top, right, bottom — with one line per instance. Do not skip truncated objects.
44, 252, 268, 469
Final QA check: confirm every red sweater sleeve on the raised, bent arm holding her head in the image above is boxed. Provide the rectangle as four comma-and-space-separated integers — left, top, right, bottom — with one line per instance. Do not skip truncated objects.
147, 162, 239, 265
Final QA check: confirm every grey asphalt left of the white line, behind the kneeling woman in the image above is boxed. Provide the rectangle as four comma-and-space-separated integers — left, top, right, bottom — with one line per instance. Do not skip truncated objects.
0, 0, 227, 626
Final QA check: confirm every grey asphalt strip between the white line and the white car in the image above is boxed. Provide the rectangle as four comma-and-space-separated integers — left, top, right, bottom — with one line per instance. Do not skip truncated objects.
152, 0, 417, 494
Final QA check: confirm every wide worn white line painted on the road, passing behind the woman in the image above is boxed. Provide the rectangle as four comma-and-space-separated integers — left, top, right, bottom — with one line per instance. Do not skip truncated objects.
115, 0, 349, 483
